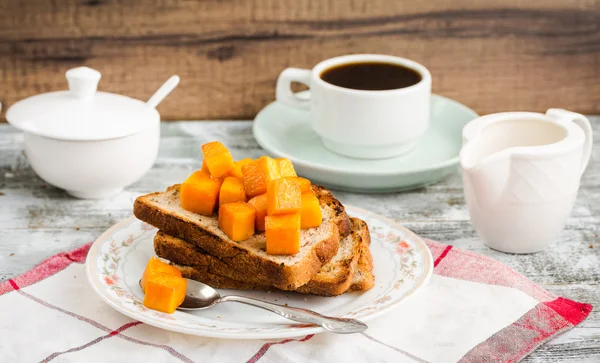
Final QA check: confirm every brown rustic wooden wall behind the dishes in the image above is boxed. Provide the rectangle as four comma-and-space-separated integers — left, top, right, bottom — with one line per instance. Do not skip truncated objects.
0, 0, 600, 119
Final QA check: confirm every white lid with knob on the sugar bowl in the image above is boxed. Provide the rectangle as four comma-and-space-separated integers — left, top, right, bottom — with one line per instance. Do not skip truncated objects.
6, 67, 160, 141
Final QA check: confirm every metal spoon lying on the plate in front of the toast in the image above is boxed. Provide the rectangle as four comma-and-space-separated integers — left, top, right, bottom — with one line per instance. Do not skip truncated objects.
140, 279, 367, 334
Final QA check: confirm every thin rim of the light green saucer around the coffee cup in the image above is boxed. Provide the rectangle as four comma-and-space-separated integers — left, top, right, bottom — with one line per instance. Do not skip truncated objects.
252, 90, 480, 176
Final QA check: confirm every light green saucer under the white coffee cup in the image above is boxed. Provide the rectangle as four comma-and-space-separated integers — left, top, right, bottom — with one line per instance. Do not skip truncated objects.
253, 92, 478, 193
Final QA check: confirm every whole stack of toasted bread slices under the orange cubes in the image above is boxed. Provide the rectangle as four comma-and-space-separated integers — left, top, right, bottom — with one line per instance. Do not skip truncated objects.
134, 185, 374, 296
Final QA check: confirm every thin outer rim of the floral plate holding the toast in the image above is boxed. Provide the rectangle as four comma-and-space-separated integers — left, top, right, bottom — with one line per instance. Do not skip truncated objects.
85, 205, 434, 339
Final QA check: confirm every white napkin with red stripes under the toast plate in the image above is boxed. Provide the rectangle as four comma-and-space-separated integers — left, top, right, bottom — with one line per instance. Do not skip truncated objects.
0, 241, 592, 363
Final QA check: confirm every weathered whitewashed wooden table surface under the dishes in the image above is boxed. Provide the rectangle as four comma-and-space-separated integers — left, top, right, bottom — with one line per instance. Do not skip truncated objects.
0, 117, 600, 362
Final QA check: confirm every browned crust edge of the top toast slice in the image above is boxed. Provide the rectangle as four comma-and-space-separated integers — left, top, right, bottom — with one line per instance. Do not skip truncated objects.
133, 185, 350, 290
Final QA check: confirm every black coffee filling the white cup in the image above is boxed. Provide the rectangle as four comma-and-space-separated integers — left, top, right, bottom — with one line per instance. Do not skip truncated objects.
321, 62, 422, 91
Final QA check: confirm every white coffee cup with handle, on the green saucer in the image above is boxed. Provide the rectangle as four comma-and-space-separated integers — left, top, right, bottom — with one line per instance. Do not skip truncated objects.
277, 54, 431, 159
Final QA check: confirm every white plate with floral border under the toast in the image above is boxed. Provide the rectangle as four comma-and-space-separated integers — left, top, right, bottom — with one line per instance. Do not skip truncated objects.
86, 207, 433, 339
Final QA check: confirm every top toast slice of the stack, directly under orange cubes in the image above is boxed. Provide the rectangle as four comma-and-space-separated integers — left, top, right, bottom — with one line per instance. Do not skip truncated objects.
133, 185, 350, 290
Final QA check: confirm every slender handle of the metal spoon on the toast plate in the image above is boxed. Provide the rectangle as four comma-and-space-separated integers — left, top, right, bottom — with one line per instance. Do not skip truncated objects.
219, 295, 367, 334
